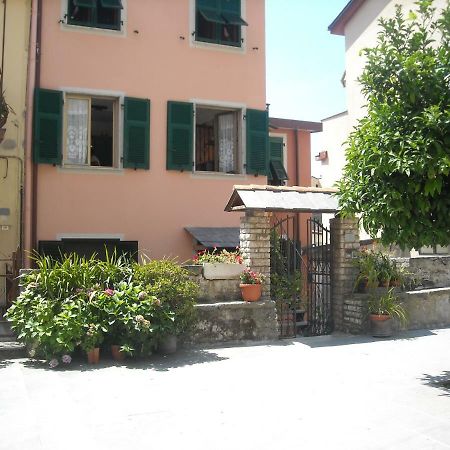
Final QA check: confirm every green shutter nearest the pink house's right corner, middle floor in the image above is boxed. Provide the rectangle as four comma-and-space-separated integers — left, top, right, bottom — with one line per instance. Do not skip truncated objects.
245, 109, 269, 175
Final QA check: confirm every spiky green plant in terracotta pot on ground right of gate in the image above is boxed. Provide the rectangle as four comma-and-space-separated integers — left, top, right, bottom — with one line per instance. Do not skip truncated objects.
368, 288, 407, 337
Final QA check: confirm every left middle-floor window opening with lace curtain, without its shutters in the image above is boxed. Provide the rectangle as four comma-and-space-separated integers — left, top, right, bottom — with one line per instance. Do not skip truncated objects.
64, 96, 118, 167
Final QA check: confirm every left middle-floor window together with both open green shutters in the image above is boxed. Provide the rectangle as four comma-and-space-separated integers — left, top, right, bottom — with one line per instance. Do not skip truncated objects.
33, 89, 150, 169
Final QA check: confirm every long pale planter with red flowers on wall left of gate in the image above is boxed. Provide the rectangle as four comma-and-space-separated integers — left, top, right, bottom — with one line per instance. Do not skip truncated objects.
193, 247, 244, 280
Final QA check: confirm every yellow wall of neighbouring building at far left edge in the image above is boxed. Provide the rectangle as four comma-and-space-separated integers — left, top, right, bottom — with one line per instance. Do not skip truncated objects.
0, 0, 31, 306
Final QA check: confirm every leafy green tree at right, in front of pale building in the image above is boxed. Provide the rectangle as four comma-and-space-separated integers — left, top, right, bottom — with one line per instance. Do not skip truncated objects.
338, 0, 450, 248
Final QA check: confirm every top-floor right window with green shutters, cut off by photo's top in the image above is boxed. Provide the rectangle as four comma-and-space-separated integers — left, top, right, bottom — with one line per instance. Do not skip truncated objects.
195, 0, 248, 47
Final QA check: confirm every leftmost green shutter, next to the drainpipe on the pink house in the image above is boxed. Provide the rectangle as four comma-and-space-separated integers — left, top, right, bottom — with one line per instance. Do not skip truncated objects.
33, 89, 63, 164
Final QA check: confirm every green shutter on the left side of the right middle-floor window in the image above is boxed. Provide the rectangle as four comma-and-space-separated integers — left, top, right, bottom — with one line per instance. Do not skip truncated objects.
167, 101, 194, 170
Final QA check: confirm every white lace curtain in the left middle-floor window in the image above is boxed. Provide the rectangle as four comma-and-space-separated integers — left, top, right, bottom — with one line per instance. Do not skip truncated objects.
67, 98, 89, 164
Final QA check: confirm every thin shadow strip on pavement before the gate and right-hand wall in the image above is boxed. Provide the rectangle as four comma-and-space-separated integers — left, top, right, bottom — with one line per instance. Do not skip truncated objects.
293, 330, 435, 348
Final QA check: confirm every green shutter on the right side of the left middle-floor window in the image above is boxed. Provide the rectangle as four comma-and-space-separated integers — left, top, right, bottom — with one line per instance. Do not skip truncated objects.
123, 97, 150, 170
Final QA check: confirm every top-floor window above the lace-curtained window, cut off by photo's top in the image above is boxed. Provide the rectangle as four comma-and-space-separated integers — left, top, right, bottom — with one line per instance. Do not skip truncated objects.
67, 0, 123, 30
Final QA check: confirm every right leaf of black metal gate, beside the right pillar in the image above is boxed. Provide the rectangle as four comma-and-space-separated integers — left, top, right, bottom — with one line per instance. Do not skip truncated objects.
305, 219, 332, 336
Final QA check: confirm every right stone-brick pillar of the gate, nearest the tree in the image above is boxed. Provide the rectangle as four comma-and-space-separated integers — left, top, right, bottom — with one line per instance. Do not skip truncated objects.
330, 217, 359, 331
